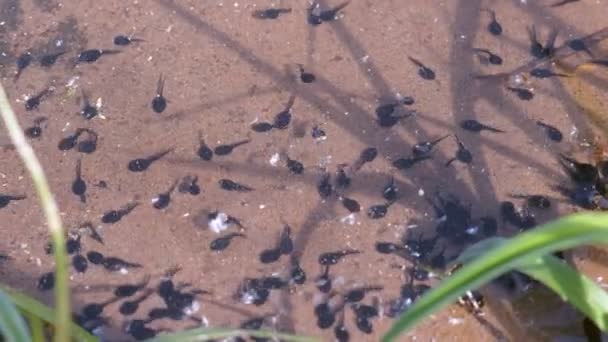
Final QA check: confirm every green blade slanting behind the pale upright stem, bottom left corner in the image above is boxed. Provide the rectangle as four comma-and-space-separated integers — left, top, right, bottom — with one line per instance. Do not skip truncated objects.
0, 284, 98, 342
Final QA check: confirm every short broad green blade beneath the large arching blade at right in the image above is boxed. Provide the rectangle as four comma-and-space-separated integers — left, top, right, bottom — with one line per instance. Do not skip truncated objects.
518, 255, 608, 331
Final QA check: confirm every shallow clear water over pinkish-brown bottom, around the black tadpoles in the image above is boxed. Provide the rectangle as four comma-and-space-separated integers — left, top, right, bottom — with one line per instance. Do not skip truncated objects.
0, 0, 608, 341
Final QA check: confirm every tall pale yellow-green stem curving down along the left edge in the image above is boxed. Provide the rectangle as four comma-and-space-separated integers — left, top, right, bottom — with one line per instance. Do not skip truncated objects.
0, 84, 71, 342
